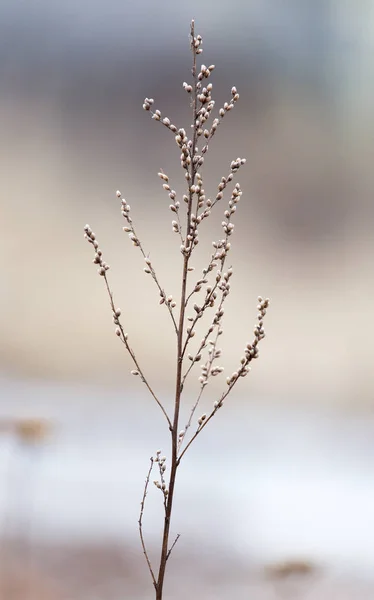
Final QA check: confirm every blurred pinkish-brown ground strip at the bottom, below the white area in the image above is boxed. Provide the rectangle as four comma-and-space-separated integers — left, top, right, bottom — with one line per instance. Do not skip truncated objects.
0, 545, 374, 600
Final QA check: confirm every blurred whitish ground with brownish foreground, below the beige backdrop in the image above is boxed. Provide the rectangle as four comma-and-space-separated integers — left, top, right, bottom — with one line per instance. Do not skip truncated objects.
0, 380, 374, 600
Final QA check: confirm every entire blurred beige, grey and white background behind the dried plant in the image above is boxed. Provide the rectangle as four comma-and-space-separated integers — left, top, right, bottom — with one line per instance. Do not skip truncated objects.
0, 0, 374, 600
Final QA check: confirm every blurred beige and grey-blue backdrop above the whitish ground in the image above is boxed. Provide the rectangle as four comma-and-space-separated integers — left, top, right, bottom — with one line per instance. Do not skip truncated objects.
0, 2, 373, 409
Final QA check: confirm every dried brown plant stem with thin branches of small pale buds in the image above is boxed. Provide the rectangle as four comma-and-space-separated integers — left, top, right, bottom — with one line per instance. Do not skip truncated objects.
84, 21, 269, 600
